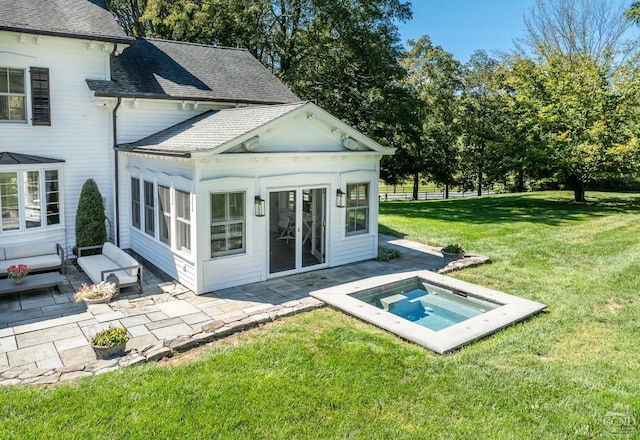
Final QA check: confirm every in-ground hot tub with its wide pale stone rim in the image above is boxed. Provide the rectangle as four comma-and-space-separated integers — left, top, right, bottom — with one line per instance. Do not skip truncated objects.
311, 270, 546, 354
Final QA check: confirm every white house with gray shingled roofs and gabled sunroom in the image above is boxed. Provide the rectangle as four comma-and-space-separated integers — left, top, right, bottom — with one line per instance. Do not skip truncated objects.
0, 0, 393, 293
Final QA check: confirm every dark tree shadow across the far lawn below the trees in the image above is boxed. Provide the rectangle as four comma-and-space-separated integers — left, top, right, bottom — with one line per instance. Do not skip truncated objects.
380, 192, 640, 227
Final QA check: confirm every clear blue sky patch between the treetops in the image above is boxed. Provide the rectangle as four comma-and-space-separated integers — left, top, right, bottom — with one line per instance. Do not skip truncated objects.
399, 0, 535, 63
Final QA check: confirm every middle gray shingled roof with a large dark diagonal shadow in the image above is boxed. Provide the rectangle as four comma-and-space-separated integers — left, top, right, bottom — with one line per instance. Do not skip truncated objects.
87, 38, 300, 104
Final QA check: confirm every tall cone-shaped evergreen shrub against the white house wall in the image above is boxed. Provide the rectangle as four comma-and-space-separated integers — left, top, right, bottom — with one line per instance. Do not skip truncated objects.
76, 179, 107, 247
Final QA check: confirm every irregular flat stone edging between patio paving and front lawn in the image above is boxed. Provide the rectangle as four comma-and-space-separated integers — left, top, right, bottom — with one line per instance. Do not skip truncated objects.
0, 297, 326, 386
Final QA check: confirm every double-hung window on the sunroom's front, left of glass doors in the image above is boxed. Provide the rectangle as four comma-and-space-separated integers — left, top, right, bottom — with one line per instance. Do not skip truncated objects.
211, 192, 246, 257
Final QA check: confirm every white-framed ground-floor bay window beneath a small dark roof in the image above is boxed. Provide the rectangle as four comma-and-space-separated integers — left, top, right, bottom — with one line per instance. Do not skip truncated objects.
0, 168, 61, 233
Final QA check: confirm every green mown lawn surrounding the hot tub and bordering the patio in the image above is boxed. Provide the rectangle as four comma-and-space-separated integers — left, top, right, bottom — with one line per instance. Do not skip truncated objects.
0, 193, 640, 439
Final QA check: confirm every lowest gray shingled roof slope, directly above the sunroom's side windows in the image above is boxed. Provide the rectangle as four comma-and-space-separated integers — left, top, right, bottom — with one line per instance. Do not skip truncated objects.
120, 103, 304, 155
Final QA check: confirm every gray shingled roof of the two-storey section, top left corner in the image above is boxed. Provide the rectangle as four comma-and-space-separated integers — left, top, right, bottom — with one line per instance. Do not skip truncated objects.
0, 0, 134, 43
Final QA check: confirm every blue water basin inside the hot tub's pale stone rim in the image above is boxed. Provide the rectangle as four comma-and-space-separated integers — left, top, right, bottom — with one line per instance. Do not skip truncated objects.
353, 281, 500, 331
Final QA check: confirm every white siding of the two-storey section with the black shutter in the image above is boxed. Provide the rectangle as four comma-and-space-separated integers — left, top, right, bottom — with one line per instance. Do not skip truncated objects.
0, 31, 113, 253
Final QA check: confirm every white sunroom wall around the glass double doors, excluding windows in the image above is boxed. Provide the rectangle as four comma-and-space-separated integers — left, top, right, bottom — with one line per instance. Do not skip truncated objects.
198, 153, 379, 293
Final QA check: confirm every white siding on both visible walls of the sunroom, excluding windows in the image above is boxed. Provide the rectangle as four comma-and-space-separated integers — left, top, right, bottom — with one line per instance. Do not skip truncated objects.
120, 122, 380, 293
